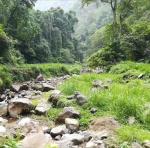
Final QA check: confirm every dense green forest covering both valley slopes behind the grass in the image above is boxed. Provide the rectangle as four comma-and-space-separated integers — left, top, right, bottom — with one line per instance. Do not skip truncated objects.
0, 0, 150, 67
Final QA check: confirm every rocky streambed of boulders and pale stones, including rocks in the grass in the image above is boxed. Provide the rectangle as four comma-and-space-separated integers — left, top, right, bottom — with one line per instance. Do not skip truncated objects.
0, 75, 150, 148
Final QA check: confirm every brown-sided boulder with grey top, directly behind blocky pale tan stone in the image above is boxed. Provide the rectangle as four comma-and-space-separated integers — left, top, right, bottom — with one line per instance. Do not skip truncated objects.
55, 107, 80, 124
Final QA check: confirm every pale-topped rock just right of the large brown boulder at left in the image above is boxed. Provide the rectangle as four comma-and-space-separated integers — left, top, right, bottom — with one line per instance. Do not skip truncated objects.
35, 103, 50, 115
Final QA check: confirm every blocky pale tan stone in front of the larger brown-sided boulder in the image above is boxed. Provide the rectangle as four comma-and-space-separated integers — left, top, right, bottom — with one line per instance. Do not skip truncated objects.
65, 118, 79, 132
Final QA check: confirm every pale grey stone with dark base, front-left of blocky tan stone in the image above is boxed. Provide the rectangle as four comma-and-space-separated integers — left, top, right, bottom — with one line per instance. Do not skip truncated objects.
51, 125, 69, 137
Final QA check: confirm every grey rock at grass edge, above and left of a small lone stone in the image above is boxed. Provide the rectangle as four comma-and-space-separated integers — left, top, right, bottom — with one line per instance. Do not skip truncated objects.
74, 92, 87, 105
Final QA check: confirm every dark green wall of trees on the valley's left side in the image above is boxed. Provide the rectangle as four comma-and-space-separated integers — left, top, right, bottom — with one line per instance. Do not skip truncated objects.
0, 0, 82, 64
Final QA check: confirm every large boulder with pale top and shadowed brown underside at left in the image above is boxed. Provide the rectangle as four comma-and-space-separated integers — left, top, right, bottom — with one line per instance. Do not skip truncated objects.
8, 98, 34, 118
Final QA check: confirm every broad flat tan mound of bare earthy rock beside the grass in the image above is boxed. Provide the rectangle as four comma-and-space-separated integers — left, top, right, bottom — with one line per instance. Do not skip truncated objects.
90, 116, 119, 133
